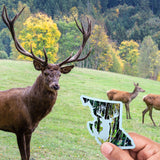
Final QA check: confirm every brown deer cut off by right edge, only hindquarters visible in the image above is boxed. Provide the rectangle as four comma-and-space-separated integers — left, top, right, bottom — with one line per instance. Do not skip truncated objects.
142, 94, 160, 126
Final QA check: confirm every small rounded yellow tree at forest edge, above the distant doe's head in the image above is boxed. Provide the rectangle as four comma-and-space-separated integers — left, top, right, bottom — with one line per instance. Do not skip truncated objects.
119, 40, 139, 75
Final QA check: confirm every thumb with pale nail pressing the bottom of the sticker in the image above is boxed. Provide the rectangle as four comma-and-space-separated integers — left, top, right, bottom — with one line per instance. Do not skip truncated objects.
101, 142, 133, 160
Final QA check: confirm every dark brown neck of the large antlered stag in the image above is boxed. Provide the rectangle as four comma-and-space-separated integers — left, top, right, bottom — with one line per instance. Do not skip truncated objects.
26, 75, 57, 123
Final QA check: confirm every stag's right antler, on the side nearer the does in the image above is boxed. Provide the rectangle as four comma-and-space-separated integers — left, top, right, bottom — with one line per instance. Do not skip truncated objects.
58, 18, 91, 66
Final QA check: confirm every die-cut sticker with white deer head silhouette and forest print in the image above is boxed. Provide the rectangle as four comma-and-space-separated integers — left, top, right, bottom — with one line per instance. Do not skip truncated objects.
81, 95, 135, 149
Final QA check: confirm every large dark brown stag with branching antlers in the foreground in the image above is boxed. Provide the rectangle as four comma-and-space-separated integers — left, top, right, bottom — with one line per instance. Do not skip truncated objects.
0, 6, 91, 160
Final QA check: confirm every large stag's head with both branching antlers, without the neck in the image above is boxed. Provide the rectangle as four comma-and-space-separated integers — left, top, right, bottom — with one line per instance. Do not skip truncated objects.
2, 6, 91, 91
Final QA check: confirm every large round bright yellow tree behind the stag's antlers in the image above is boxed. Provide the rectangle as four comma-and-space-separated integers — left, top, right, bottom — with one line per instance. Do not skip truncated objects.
18, 13, 61, 63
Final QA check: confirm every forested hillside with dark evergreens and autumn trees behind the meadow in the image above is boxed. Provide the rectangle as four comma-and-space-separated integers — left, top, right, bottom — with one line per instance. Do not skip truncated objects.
0, 0, 160, 80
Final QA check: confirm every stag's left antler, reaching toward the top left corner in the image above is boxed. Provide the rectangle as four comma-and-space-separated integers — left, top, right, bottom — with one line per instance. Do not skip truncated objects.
2, 6, 48, 66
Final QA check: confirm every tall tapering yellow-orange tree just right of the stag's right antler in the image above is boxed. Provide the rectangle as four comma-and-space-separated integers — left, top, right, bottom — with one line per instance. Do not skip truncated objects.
90, 25, 113, 70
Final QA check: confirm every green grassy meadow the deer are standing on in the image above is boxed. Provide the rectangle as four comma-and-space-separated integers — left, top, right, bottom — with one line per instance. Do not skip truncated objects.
0, 60, 160, 160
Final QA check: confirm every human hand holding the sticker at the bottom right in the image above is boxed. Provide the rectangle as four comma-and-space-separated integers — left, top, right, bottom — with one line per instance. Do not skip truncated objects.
101, 133, 160, 160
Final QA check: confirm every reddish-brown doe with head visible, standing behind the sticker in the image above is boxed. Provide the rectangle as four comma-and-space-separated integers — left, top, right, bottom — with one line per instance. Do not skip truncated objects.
107, 83, 145, 119
